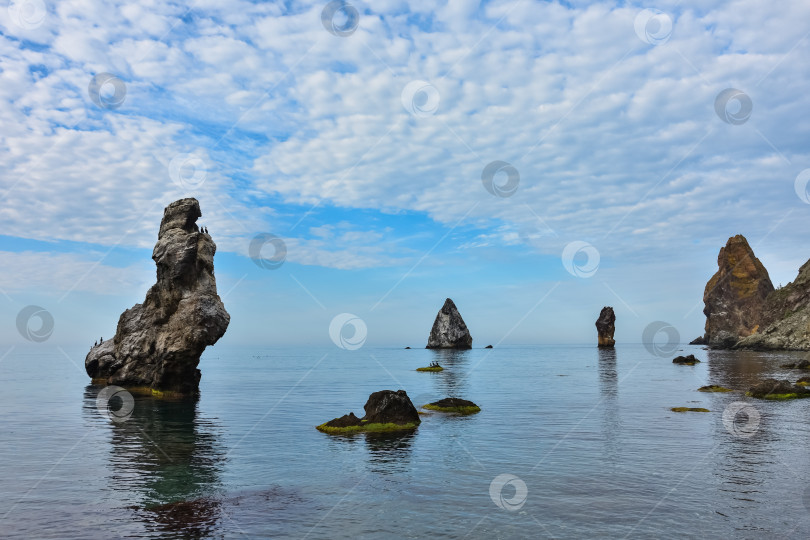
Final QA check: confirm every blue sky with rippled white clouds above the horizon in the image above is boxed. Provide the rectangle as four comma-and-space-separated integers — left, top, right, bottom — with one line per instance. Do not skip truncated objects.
0, 0, 810, 348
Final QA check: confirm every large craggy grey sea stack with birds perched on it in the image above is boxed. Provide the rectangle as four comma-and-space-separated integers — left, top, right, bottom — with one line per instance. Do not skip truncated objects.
84, 198, 231, 395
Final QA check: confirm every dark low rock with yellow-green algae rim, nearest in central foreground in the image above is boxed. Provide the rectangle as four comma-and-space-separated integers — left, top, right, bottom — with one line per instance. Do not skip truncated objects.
317, 390, 422, 434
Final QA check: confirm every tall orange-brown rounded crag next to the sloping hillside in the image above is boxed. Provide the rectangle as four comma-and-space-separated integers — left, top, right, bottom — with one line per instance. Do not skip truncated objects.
703, 235, 774, 348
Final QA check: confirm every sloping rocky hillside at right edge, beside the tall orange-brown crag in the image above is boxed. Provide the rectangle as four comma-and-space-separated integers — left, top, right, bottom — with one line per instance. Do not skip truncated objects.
736, 261, 810, 351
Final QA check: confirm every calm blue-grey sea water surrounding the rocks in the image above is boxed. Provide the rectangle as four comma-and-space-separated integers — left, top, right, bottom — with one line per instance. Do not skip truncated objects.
0, 343, 810, 538
